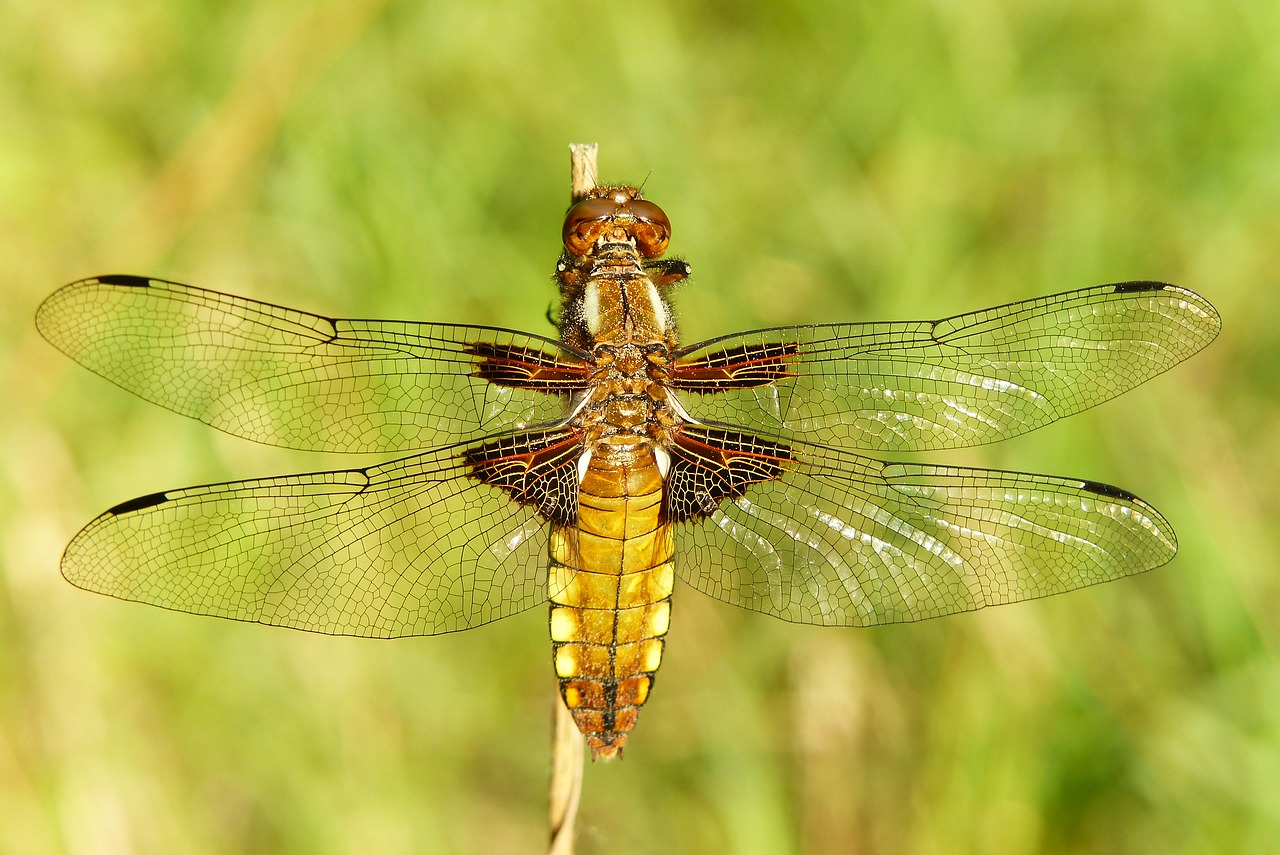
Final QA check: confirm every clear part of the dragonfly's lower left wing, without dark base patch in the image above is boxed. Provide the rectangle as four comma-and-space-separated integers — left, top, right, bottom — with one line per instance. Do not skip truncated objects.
61, 448, 548, 637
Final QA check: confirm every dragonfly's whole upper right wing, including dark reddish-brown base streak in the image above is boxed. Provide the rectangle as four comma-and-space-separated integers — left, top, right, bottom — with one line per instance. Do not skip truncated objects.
673, 282, 1221, 452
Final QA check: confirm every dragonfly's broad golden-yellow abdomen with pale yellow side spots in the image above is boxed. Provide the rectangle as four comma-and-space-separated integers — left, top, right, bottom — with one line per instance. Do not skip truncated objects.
550, 442, 675, 758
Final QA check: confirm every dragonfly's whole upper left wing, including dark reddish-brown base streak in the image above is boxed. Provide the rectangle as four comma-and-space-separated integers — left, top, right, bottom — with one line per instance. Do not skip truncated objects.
36, 276, 586, 452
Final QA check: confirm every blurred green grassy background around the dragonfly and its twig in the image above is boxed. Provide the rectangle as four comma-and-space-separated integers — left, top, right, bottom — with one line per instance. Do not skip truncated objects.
0, 0, 1280, 855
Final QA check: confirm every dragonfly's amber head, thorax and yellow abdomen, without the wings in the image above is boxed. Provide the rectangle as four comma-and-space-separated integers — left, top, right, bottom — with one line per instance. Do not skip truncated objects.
550, 188, 682, 758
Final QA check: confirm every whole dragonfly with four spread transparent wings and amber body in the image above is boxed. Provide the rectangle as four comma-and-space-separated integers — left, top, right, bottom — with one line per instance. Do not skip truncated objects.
37, 186, 1221, 758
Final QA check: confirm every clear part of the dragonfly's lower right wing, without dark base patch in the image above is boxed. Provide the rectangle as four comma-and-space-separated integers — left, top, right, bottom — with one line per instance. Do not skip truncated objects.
676, 445, 1178, 626
